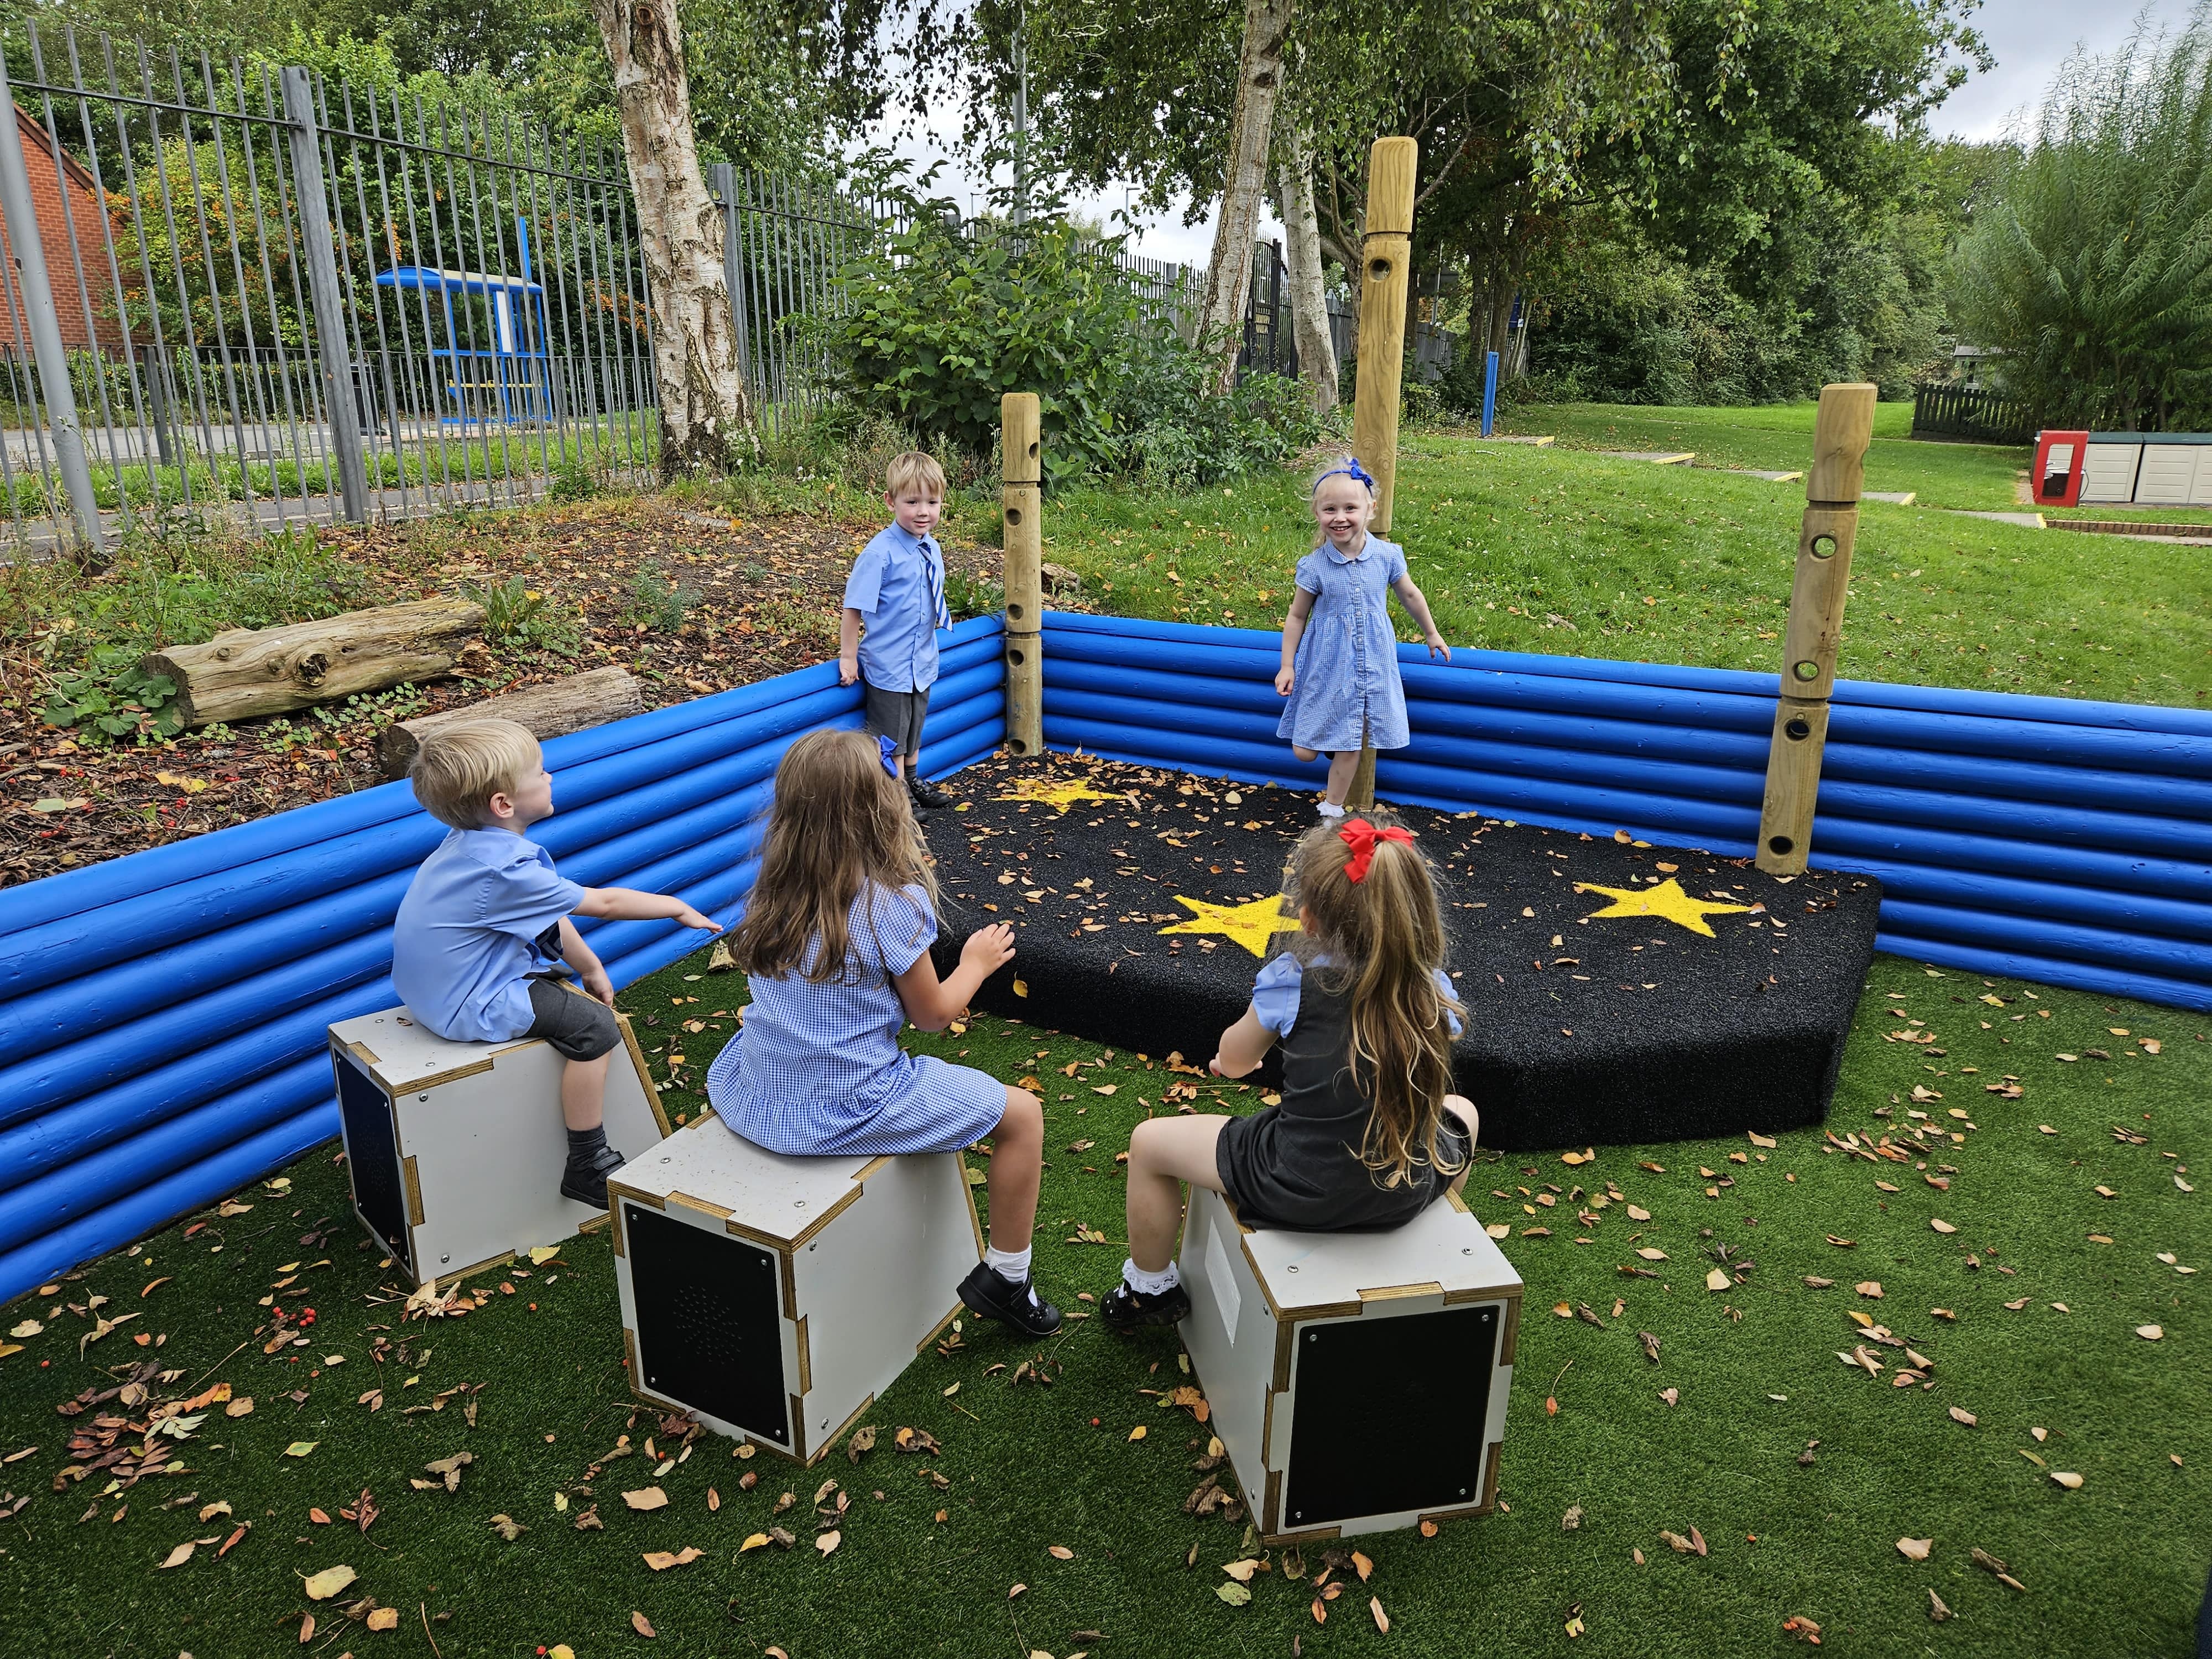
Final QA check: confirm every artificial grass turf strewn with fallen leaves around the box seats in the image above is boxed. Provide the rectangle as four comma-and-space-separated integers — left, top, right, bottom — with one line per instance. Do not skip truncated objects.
0, 956, 2212, 1659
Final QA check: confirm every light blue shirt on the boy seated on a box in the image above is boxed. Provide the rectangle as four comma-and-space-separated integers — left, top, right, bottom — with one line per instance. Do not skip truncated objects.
392, 830, 584, 1042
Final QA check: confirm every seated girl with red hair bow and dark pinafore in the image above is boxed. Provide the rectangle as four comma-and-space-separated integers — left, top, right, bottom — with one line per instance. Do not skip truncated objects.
1099, 814, 1478, 1329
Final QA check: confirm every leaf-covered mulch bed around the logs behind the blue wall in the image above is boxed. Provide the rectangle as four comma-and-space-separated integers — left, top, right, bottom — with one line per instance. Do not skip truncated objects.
0, 498, 1018, 887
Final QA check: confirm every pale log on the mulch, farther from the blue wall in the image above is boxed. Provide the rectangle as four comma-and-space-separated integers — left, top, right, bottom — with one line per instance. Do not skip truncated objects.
144, 599, 484, 726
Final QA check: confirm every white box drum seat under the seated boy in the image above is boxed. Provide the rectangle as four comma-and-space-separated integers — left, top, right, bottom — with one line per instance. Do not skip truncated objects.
330, 991, 668, 1285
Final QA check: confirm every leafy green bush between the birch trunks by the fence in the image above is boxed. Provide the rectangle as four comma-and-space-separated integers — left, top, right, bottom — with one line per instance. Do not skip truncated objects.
825, 201, 1318, 487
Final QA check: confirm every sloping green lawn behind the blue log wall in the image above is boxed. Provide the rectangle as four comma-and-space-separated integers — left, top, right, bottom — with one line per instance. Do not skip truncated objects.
1031, 436, 2212, 706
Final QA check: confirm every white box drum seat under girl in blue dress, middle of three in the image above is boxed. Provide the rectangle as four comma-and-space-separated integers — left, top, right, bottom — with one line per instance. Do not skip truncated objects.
606, 1113, 982, 1462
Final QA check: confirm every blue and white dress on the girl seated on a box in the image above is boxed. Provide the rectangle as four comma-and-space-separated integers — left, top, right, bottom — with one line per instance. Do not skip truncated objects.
706, 883, 1006, 1157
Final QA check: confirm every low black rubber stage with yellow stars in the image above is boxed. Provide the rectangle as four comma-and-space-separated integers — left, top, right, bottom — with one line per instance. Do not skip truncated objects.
925, 757, 1880, 1150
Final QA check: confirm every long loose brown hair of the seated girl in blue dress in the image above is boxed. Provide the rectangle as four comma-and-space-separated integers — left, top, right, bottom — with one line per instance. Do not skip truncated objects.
730, 732, 938, 984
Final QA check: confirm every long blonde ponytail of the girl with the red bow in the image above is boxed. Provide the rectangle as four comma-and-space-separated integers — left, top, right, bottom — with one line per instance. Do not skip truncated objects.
1292, 812, 1464, 1186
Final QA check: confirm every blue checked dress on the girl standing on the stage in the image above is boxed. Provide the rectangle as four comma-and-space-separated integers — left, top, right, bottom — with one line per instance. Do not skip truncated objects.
1274, 535, 1413, 754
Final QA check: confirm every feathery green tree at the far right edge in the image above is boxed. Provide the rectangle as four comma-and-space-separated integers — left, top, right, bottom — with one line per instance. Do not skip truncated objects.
1955, 0, 2212, 431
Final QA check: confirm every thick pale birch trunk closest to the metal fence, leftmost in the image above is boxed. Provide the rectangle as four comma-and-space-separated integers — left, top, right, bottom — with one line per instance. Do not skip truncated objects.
591, 0, 752, 480
